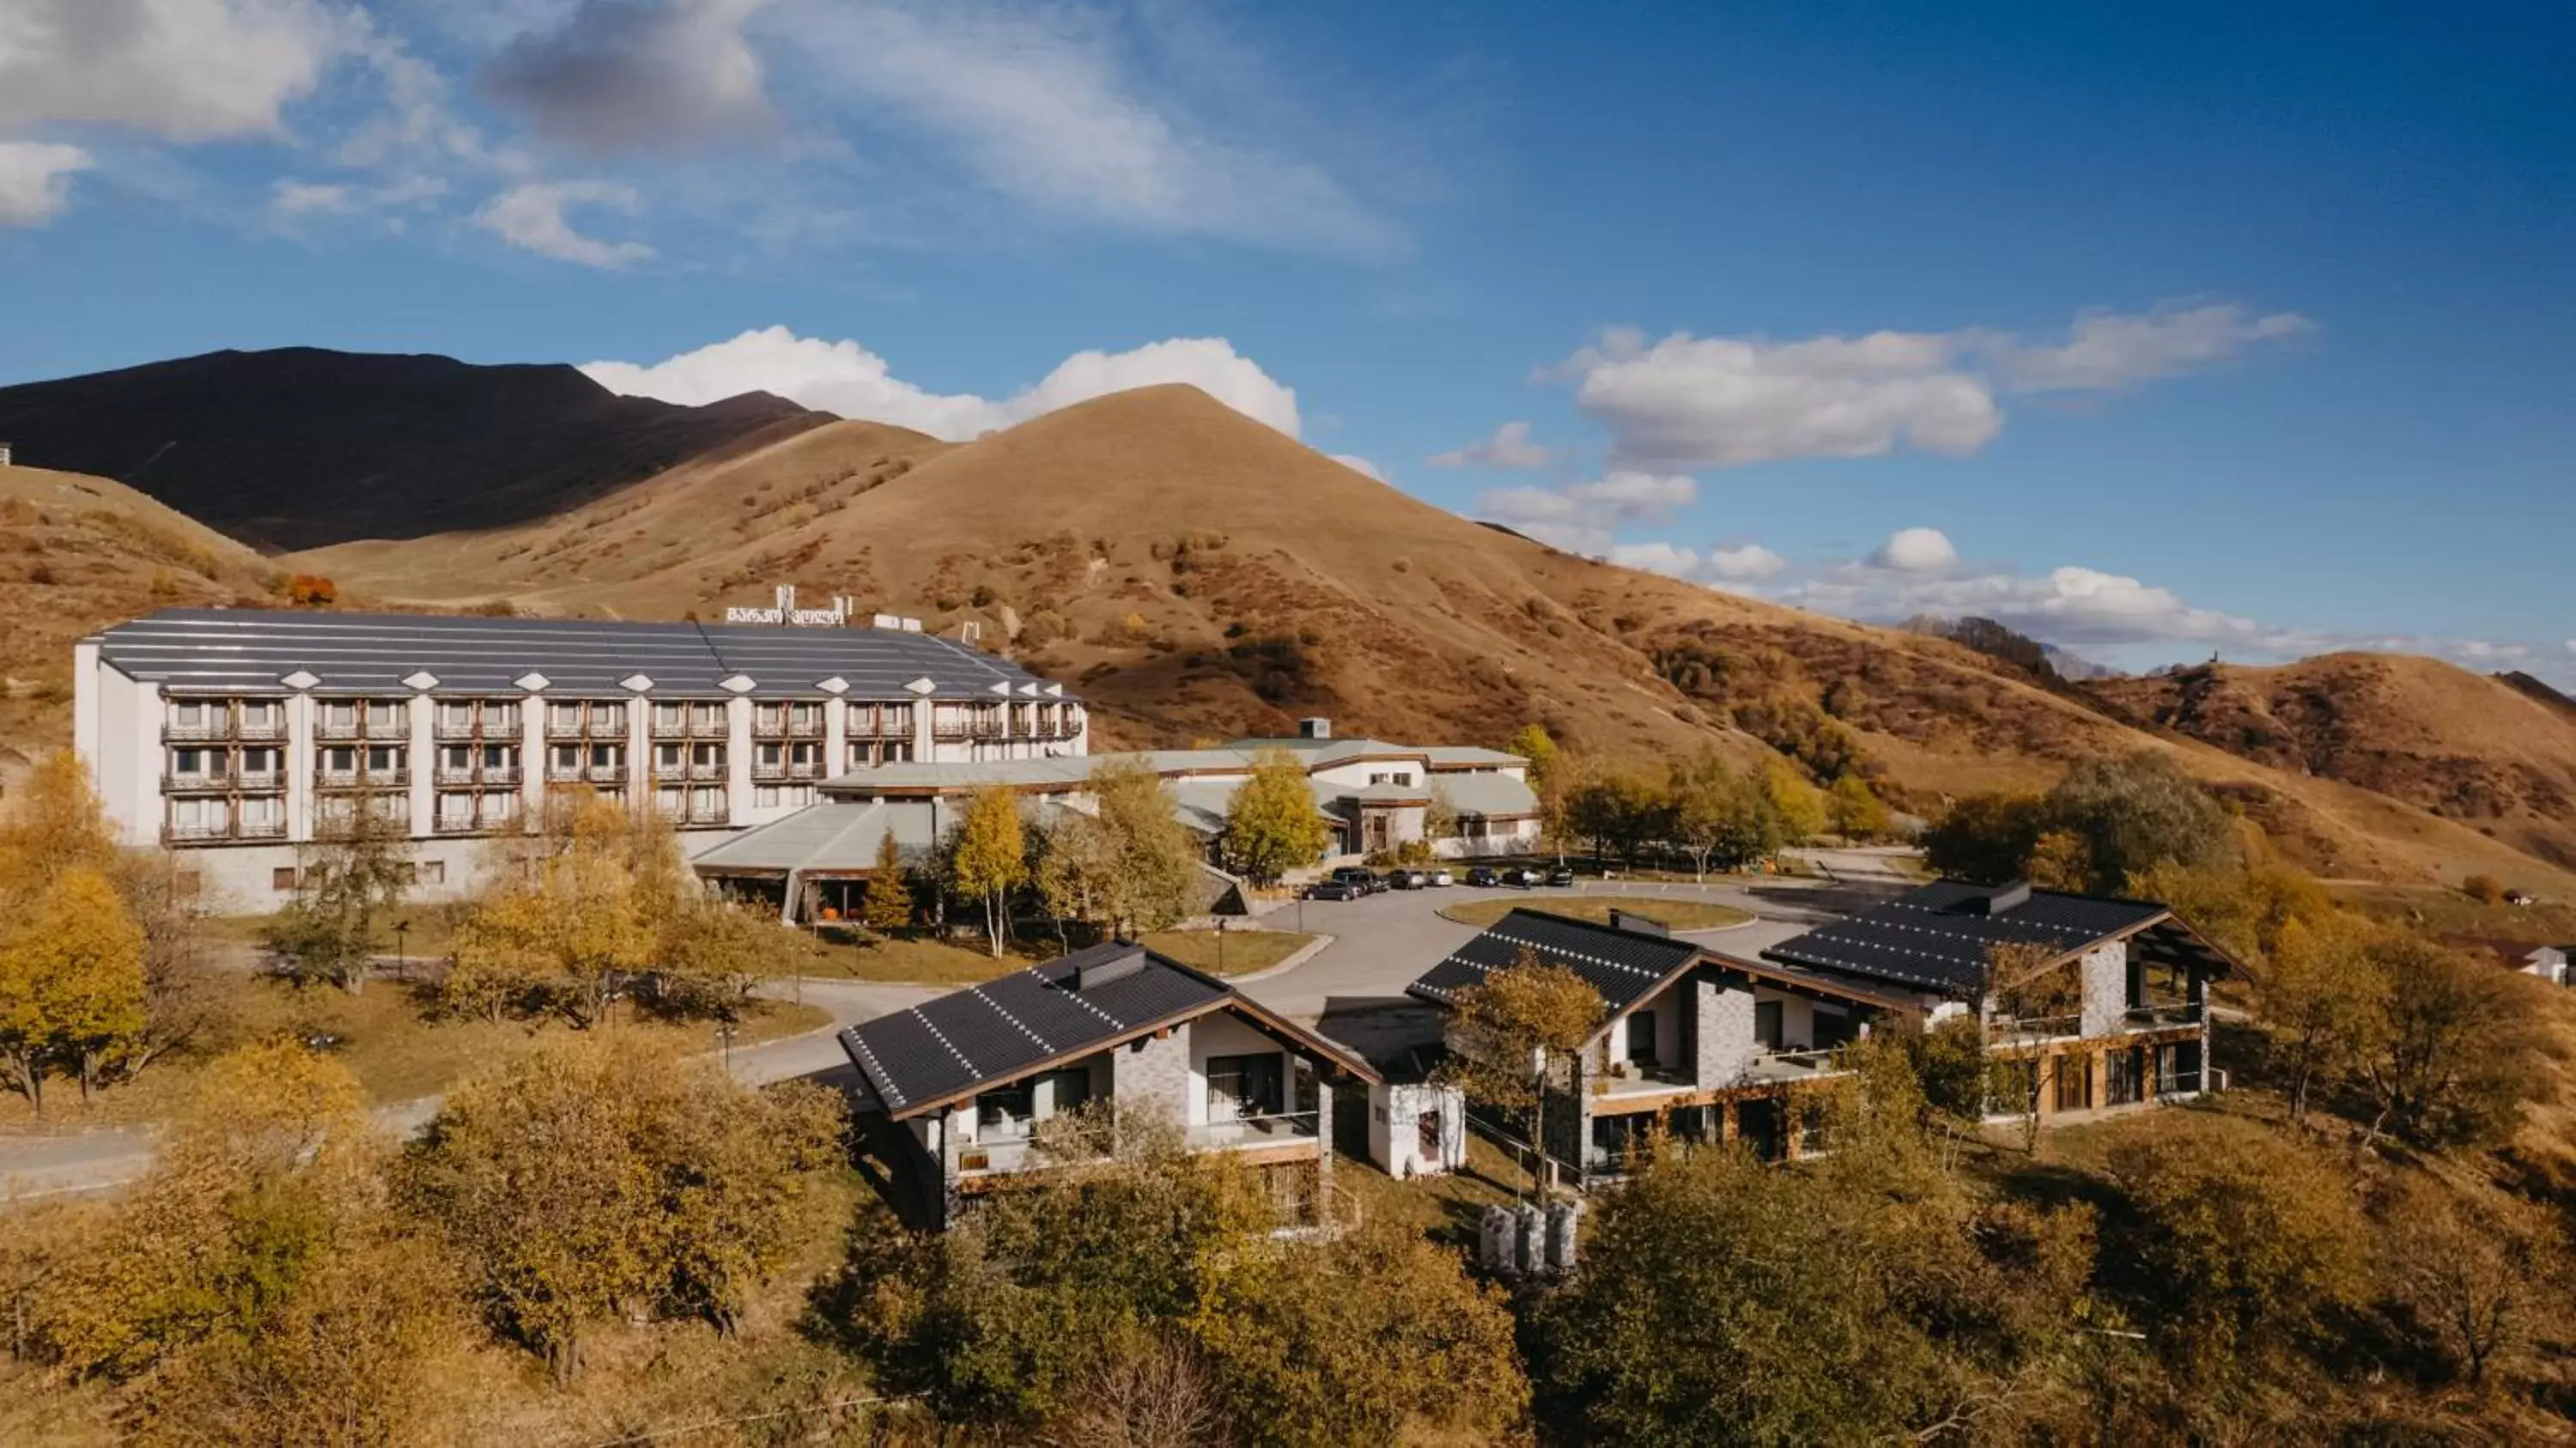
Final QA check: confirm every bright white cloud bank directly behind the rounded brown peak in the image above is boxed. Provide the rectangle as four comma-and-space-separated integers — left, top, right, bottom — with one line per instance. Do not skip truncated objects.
582, 327, 1298, 438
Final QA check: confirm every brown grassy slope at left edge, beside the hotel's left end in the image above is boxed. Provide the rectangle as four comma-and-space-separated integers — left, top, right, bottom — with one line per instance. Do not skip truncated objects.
0, 466, 286, 781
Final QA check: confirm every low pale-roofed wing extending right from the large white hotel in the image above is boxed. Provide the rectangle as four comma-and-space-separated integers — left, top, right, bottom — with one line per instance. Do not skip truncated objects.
696, 719, 1538, 920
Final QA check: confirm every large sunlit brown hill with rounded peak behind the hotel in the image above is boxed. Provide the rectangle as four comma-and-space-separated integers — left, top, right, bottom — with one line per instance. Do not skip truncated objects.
289, 386, 2576, 886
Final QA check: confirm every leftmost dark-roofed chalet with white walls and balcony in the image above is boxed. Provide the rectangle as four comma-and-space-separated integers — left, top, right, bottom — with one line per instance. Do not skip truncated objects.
840, 943, 1378, 1229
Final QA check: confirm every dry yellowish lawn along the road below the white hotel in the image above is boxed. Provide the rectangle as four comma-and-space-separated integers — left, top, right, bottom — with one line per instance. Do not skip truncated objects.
0, 976, 832, 1134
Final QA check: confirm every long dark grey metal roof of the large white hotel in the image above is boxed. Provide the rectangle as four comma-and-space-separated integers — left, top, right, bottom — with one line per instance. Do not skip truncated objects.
95, 608, 1046, 698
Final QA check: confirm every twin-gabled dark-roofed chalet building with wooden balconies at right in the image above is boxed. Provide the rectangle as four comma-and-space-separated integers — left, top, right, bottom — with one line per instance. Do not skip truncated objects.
1406, 881, 2233, 1185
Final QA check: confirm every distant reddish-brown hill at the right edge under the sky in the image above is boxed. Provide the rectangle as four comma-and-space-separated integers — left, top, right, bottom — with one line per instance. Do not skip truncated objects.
2087, 654, 2576, 866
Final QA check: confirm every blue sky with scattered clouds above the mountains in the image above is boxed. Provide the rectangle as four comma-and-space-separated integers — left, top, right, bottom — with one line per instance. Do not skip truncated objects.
0, 0, 2576, 685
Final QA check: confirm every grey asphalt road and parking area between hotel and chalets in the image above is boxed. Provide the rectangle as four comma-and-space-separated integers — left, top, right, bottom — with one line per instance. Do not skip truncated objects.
0, 871, 1886, 1206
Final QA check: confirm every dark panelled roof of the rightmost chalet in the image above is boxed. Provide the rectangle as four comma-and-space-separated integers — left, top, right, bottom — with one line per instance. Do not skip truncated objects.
1762, 881, 2166, 997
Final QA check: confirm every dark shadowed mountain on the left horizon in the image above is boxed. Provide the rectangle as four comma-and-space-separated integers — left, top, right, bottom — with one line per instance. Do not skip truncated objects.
0, 348, 829, 549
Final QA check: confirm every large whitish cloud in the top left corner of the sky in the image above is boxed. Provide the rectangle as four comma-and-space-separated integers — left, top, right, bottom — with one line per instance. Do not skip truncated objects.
0, 0, 368, 142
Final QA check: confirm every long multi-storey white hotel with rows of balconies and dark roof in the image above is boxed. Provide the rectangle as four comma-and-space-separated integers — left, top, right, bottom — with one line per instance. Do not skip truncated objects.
72, 608, 1090, 910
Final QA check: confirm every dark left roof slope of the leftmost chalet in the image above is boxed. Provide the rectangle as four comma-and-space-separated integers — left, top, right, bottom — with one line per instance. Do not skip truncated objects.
840, 943, 1234, 1116
